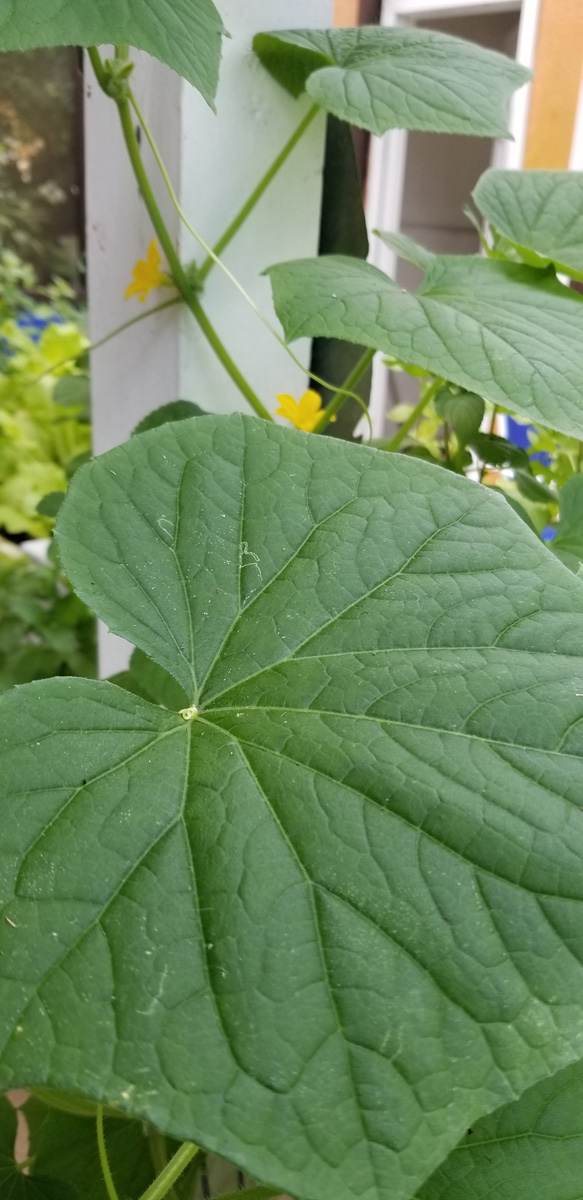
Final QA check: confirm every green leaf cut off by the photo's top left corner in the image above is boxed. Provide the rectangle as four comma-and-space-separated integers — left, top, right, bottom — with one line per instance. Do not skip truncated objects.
0, 0, 224, 103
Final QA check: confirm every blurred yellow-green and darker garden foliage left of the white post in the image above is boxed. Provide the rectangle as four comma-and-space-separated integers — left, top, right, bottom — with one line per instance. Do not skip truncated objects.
0, 248, 95, 692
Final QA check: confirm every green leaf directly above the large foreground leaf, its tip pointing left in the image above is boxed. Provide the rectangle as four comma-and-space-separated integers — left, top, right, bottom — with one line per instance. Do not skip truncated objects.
269, 256, 583, 438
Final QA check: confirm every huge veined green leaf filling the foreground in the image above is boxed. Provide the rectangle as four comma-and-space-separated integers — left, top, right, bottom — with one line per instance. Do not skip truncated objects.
0, 416, 583, 1200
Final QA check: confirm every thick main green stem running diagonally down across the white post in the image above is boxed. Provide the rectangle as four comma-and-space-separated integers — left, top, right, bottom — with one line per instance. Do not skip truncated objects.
89, 47, 271, 421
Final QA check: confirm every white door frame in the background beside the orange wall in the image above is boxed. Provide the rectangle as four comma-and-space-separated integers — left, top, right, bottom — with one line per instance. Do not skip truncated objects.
366, 0, 541, 437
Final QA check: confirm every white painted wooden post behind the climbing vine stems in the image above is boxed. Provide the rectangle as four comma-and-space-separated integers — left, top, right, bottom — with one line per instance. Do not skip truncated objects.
85, 0, 333, 676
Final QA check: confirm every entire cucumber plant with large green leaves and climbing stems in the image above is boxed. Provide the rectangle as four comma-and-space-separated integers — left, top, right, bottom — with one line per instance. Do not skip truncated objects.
0, 0, 583, 1200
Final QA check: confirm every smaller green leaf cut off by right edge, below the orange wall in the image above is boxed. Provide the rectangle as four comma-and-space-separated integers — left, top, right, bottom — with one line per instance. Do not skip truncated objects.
474, 170, 583, 280
